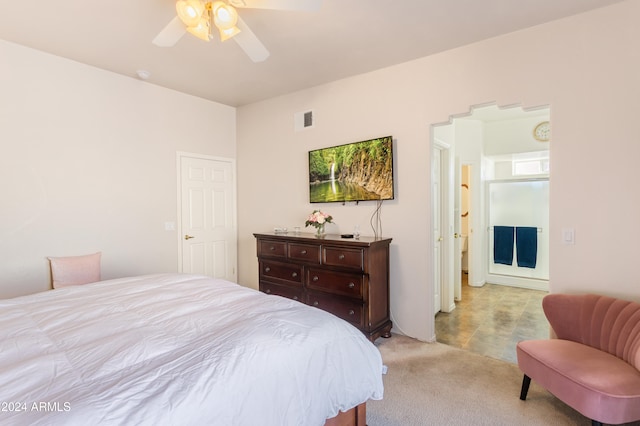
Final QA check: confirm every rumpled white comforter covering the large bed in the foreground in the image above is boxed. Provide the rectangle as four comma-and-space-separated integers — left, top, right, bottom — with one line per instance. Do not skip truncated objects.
0, 274, 383, 426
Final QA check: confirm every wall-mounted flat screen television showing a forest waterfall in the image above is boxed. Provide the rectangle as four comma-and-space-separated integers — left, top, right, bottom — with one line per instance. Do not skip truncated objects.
309, 136, 394, 203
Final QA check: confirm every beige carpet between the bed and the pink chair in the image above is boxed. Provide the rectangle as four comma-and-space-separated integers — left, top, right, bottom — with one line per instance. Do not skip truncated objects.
367, 335, 591, 426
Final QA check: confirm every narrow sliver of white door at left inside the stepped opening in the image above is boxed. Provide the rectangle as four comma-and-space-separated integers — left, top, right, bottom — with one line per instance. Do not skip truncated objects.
431, 149, 443, 314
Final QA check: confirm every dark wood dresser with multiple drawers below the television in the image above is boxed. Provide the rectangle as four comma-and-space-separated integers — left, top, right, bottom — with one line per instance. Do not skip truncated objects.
253, 233, 392, 342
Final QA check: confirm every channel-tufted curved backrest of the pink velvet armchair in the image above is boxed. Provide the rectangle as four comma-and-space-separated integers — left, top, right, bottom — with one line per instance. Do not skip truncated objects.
542, 293, 640, 370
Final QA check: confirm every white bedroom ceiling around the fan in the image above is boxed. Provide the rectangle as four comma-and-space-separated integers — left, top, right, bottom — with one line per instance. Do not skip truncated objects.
0, 0, 622, 106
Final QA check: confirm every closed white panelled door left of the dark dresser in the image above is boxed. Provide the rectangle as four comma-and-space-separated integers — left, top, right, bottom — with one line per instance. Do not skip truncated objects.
178, 153, 237, 282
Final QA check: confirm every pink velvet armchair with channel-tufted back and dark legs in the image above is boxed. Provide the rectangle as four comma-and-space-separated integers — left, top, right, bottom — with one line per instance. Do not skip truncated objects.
516, 294, 640, 425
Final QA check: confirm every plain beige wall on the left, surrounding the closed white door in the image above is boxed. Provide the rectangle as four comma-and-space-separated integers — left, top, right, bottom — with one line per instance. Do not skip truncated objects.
0, 41, 236, 297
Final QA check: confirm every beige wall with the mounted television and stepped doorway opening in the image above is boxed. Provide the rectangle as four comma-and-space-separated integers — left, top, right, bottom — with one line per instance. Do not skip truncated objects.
237, 1, 640, 340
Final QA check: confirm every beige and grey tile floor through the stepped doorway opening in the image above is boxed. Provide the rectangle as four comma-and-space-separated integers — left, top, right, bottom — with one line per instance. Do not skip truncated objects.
436, 273, 549, 363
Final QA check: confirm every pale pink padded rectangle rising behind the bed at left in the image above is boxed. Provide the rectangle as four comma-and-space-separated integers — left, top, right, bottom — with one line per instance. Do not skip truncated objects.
49, 252, 102, 288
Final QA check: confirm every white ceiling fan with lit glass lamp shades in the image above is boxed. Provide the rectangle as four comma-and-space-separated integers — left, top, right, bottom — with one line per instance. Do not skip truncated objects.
152, 0, 322, 62
